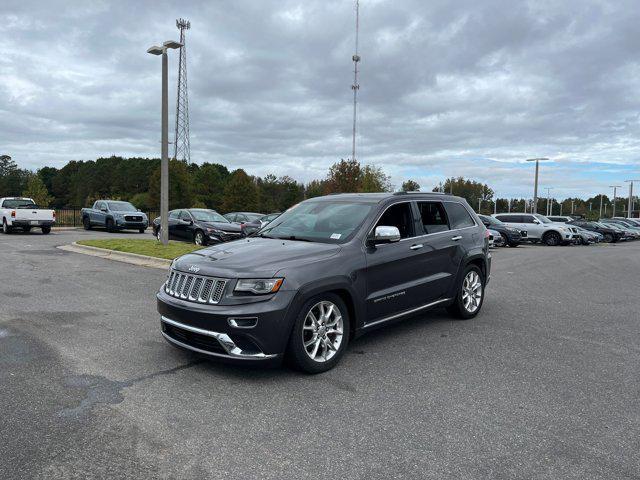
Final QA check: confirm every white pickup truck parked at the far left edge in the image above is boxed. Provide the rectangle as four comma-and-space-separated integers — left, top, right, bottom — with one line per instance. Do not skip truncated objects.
0, 197, 56, 235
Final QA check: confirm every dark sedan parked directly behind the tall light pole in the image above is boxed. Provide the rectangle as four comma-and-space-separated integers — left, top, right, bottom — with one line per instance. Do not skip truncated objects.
153, 208, 244, 245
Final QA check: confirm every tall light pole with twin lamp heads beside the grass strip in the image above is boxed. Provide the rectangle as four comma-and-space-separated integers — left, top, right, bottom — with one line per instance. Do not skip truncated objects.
147, 40, 182, 245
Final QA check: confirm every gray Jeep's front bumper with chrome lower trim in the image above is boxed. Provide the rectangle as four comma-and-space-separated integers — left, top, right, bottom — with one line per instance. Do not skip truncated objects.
157, 289, 295, 361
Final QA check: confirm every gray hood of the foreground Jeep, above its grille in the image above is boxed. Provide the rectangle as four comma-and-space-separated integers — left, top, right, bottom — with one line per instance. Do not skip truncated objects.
173, 238, 340, 278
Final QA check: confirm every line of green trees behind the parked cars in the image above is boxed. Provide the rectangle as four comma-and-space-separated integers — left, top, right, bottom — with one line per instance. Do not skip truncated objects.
0, 156, 626, 218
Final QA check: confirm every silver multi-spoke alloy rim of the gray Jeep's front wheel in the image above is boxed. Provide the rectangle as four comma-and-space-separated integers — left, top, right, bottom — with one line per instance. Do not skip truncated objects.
302, 300, 344, 362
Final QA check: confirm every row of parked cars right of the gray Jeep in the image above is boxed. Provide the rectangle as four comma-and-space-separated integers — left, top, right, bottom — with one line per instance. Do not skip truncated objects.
479, 213, 640, 247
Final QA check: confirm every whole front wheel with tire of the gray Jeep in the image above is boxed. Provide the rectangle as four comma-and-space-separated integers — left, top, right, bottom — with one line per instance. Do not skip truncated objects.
287, 293, 350, 373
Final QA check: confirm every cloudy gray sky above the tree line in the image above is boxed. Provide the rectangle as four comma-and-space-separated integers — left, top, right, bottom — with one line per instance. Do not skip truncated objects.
0, 0, 640, 197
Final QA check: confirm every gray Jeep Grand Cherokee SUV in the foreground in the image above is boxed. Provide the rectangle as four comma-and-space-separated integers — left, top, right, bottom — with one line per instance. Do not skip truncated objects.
157, 193, 491, 373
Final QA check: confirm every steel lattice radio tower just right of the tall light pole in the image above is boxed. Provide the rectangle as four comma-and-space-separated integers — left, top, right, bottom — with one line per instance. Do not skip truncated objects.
173, 18, 191, 163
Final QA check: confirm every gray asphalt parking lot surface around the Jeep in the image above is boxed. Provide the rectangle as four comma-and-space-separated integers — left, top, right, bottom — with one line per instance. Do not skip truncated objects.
0, 231, 640, 479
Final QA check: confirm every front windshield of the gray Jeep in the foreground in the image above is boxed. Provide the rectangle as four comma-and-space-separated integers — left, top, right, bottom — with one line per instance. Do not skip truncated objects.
258, 201, 372, 243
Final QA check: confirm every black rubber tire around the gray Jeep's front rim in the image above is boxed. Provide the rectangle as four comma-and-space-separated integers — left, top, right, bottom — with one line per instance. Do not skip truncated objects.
287, 293, 351, 374
